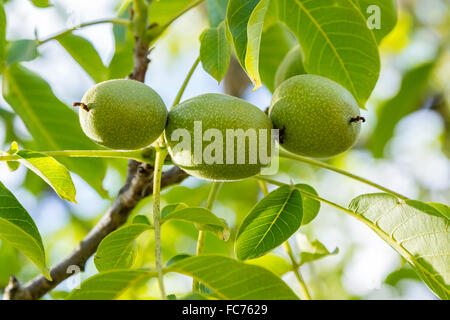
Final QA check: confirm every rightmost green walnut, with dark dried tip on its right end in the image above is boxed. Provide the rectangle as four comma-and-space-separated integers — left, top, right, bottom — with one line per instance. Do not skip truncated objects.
269, 75, 365, 158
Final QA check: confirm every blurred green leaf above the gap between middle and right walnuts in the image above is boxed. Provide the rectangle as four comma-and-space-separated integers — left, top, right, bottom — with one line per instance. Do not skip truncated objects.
259, 22, 297, 92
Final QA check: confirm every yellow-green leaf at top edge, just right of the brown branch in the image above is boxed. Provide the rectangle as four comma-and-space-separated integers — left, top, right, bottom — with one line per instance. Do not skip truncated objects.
149, 0, 203, 27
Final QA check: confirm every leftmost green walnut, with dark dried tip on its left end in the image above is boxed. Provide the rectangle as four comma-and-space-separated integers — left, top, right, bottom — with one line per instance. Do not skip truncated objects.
74, 79, 167, 150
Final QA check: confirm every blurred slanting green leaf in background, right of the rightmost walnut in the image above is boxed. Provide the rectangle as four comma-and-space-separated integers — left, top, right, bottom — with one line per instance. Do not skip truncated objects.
369, 62, 435, 158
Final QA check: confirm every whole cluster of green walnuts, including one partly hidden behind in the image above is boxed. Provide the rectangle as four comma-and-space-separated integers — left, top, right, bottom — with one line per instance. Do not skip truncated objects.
77, 47, 363, 181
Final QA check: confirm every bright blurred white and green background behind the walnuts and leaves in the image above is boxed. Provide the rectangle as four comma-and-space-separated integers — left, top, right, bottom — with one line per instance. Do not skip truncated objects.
0, 0, 450, 299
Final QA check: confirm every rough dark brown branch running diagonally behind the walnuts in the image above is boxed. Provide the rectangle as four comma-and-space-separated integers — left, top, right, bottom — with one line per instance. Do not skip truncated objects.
3, 13, 188, 300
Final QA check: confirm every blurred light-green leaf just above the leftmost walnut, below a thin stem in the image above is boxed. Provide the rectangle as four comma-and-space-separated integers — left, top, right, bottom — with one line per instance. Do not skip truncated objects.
56, 33, 109, 83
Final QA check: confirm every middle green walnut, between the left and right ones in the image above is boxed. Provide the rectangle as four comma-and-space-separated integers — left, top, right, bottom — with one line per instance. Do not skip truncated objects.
165, 94, 273, 181
